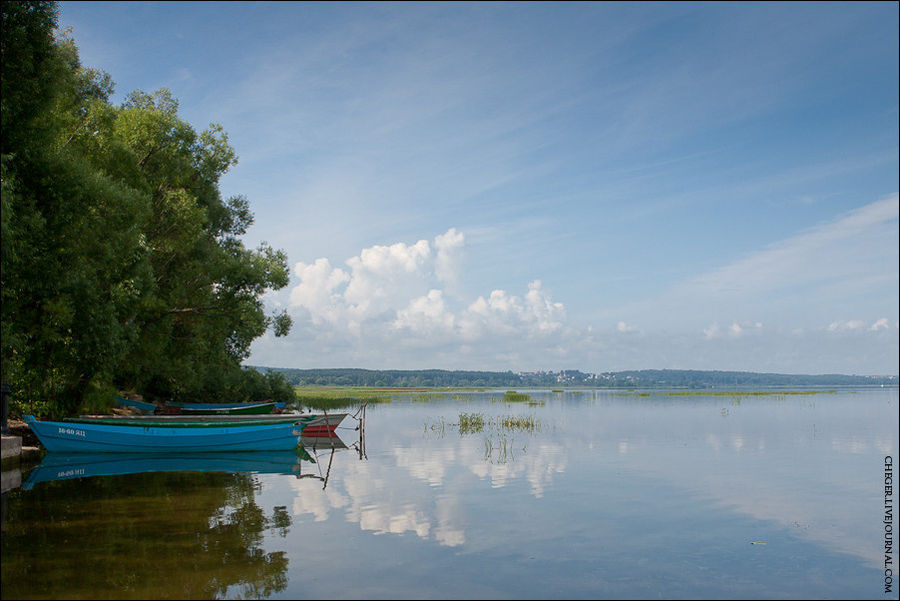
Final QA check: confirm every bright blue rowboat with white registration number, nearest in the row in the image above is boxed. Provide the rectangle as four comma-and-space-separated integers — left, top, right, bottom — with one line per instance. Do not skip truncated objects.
25, 415, 305, 453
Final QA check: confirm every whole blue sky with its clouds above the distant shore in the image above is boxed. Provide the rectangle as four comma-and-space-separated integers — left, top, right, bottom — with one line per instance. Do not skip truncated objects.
59, 2, 900, 375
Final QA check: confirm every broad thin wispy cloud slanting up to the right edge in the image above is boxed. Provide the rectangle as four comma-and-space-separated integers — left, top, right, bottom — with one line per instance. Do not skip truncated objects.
605, 193, 900, 337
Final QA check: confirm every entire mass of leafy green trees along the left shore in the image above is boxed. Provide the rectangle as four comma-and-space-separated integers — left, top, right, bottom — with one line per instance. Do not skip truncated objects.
2, 2, 292, 415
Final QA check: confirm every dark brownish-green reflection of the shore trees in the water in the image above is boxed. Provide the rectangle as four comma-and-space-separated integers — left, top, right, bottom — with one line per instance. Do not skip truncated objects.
2, 472, 291, 599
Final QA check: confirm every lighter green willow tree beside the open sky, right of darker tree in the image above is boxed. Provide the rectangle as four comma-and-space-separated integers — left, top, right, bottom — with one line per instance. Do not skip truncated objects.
109, 90, 290, 397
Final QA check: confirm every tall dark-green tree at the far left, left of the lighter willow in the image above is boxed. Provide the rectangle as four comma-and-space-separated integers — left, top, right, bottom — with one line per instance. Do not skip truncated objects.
2, 2, 149, 412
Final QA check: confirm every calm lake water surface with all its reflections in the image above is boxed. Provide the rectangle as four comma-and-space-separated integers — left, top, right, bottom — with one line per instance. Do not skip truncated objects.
0, 389, 898, 599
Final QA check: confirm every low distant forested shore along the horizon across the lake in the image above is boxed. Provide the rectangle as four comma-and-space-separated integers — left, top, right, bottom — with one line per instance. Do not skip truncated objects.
250, 367, 898, 389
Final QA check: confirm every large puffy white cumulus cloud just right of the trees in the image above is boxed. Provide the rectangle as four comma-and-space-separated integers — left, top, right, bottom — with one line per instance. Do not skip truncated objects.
290, 228, 566, 348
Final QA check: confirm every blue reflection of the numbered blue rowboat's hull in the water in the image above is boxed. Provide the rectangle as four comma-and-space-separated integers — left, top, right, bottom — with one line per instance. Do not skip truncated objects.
22, 451, 300, 490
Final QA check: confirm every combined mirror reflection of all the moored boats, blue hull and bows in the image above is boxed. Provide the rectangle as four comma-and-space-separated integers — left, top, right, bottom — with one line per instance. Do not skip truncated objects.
22, 433, 363, 490
